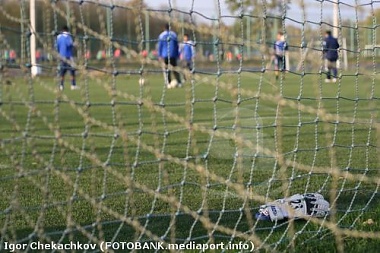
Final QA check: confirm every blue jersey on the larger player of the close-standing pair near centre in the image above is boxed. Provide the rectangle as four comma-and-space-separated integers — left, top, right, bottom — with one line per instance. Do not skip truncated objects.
158, 30, 179, 58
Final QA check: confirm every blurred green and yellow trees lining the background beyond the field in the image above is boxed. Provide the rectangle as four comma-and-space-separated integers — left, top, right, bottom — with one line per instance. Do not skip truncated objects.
0, 0, 380, 61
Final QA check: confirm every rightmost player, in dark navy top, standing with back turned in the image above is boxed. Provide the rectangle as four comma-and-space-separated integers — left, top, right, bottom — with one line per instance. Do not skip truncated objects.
323, 31, 339, 83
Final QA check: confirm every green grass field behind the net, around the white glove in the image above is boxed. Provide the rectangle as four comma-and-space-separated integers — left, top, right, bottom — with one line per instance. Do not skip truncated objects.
0, 68, 380, 252
